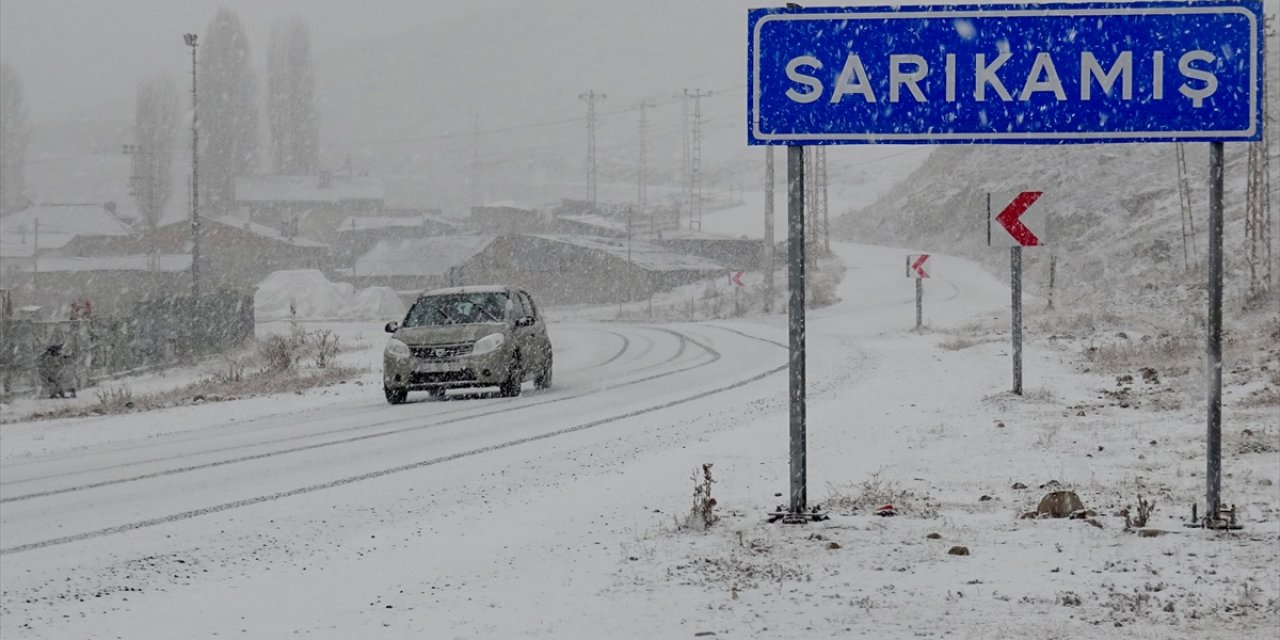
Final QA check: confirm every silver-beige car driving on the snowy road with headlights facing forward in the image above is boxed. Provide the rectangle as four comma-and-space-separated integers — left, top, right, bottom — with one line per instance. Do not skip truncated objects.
383, 285, 552, 404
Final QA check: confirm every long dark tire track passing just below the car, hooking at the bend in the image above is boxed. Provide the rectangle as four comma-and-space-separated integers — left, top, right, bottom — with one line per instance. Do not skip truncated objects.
0, 328, 722, 504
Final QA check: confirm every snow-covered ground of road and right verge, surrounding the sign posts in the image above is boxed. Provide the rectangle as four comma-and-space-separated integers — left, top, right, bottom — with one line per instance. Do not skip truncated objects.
0, 244, 1280, 639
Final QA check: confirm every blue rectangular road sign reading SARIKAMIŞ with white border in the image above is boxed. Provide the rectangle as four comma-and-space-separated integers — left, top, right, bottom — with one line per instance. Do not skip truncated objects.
746, 0, 1263, 145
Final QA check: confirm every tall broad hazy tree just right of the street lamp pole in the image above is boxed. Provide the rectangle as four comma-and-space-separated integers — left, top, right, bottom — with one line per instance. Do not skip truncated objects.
198, 9, 257, 211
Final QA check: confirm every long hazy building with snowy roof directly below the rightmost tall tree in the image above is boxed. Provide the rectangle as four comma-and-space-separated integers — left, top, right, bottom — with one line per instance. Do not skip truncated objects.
236, 173, 387, 243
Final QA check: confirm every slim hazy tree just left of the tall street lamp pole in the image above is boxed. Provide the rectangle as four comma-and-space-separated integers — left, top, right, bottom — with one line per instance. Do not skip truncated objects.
132, 76, 178, 251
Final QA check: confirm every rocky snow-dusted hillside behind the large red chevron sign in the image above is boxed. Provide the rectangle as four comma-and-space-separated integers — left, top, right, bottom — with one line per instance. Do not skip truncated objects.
833, 22, 1280, 322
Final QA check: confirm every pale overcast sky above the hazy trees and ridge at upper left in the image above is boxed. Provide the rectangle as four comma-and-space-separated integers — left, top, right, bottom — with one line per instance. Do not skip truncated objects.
0, 0, 478, 120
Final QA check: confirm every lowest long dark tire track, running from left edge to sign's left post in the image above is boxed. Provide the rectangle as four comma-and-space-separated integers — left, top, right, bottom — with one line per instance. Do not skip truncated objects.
0, 329, 787, 556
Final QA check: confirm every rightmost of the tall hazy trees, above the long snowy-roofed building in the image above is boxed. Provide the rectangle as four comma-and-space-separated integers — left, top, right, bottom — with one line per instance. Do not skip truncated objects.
266, 15, 320, 175
